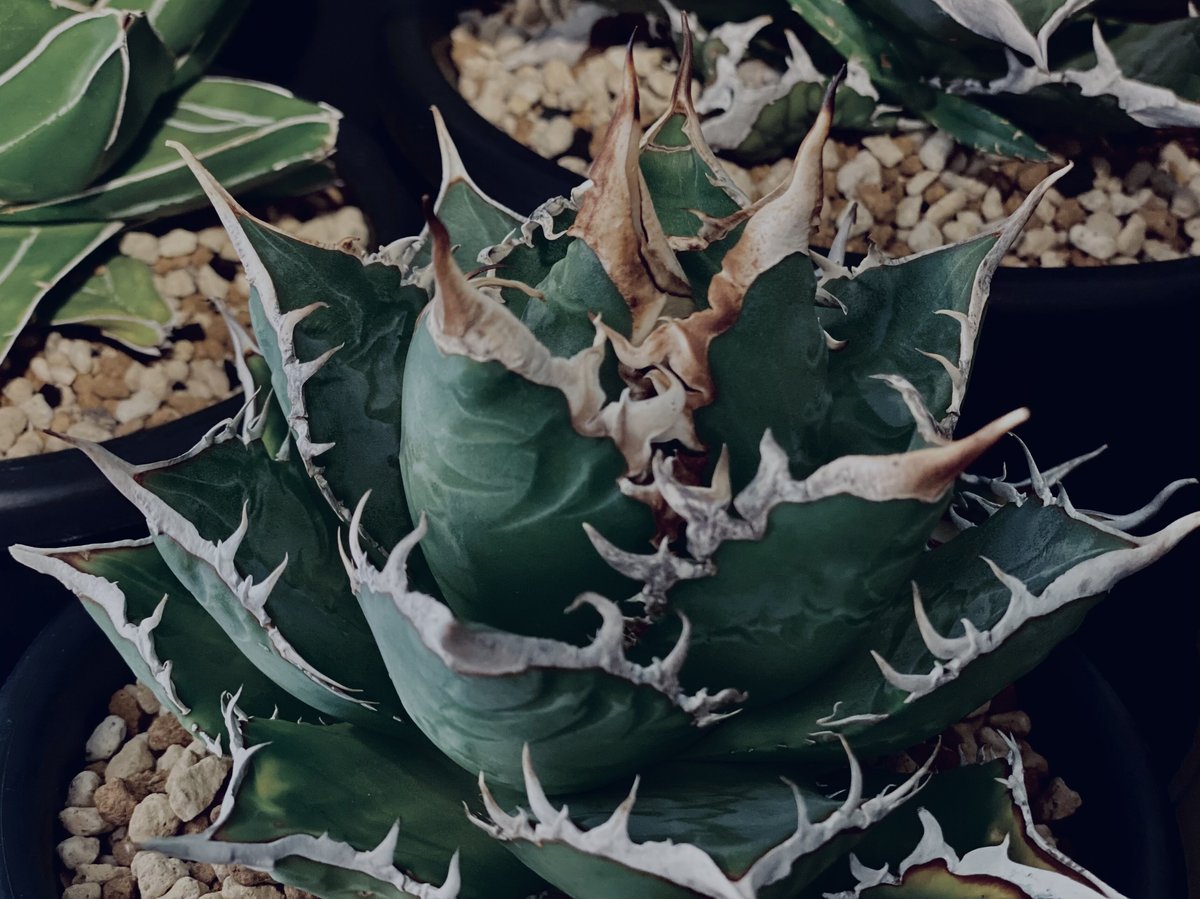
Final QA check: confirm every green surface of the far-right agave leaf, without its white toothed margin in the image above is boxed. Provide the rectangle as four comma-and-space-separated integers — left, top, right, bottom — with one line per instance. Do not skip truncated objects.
694, 499, 1129, 759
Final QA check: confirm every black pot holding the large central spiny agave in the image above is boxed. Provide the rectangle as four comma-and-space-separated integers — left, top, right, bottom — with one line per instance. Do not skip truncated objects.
0, 605, 1183, 899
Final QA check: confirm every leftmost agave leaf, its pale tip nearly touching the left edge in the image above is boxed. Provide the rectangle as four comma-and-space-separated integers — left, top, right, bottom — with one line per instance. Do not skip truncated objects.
10, 538, 316, 747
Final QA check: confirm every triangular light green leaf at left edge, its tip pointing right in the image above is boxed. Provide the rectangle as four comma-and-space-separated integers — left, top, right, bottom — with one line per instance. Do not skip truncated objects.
0, 222, 121, 361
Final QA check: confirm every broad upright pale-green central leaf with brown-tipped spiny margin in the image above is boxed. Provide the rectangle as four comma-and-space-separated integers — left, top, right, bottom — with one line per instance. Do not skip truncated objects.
401, 213, 674, 637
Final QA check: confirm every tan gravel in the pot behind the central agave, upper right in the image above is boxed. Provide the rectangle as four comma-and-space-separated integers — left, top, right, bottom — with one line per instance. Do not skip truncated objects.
450, 0, 1200, 268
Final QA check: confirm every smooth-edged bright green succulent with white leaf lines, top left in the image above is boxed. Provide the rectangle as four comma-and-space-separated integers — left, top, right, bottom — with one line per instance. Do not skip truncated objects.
0, 0, 338, 361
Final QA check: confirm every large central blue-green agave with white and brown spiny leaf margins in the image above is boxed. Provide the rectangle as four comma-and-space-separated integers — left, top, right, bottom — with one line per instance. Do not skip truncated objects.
12, 49, 1200, 899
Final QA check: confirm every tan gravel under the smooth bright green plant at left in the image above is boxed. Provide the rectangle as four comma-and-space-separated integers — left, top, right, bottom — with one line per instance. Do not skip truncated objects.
0, 188, 367, 460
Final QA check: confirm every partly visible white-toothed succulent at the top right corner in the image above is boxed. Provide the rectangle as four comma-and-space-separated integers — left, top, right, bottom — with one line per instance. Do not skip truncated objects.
664, 0, 1200, 161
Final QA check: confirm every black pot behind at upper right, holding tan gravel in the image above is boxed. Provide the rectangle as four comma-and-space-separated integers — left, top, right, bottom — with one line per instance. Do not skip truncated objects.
380, 0, 1200, 783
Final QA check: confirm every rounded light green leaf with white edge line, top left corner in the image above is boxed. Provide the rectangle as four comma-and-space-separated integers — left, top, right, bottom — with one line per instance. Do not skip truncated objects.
0, 8, 172, 203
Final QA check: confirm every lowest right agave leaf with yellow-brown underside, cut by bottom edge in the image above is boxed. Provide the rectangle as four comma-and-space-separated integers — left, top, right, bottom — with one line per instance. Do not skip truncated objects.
824, 738, 1123, 899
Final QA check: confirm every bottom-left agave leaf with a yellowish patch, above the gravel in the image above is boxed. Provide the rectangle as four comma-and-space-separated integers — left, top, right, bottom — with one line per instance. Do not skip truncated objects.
152, 696, 544, 899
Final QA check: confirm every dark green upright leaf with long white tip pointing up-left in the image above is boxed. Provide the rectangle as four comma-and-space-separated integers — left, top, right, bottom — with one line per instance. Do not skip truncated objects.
176, 146, 428, 547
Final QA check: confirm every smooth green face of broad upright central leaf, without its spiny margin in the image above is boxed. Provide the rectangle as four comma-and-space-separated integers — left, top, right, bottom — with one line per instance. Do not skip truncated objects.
401, 319, 654, 639
